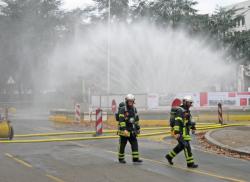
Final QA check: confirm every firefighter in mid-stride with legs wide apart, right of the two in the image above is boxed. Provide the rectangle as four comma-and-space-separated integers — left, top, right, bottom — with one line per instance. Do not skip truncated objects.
166, 96, 198, 168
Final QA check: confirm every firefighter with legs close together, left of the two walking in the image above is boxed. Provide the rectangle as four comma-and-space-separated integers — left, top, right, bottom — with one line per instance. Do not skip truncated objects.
118, 94, 142, 163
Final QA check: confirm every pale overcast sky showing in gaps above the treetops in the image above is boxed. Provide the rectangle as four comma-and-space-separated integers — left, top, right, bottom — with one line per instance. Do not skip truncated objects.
64, 0, 246, 13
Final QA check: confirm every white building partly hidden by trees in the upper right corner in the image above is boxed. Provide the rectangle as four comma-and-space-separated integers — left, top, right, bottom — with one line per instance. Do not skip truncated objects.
225, 0, 250, 32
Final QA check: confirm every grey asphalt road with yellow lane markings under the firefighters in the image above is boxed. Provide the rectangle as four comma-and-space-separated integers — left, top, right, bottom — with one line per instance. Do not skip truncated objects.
0, 110, 250, 182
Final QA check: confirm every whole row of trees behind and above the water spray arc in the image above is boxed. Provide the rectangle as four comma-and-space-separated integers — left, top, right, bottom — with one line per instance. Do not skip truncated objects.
0, 0, 250, 96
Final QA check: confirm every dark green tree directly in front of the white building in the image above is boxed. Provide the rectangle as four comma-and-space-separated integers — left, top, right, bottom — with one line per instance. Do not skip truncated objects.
209, 8, 250, 62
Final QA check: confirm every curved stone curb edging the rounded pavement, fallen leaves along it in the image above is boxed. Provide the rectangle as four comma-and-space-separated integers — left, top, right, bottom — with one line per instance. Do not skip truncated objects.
205, 128, 250, 155
